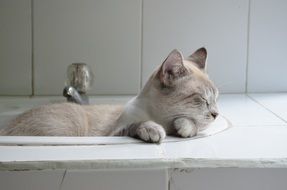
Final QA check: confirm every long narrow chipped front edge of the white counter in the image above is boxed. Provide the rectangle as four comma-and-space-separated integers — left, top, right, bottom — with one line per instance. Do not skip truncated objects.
0, 158, 287, 171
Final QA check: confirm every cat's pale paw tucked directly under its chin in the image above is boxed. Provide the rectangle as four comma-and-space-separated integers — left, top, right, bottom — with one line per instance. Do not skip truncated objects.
173, 118, 197, 138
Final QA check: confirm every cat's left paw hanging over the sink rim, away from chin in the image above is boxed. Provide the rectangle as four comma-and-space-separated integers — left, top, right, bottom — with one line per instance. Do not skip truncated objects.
136, 121, 166, 143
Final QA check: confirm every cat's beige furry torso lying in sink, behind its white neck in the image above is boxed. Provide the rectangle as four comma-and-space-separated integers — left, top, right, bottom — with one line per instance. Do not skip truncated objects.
2, 103, 123, 136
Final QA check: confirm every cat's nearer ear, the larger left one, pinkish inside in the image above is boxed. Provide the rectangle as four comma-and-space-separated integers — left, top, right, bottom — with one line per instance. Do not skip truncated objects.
159, 49, 187, 86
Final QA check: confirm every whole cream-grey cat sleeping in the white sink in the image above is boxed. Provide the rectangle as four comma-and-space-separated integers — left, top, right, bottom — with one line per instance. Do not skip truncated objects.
1, 48, 218, 143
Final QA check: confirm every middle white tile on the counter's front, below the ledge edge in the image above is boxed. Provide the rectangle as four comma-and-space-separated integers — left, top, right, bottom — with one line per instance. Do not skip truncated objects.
62, 169, 168, 190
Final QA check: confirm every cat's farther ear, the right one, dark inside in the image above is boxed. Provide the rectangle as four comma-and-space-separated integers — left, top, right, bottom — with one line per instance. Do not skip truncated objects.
188, 47, 207, 71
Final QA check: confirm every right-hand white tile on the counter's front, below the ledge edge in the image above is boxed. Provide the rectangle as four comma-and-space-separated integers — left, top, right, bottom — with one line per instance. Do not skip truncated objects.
170, 168, 287, 190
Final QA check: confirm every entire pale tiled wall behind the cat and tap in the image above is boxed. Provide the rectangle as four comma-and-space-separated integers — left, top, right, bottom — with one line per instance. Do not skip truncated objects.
0, 0, 287, 95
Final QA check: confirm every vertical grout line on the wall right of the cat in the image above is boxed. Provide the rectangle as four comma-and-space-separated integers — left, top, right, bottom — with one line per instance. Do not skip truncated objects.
245, 0, 252, 93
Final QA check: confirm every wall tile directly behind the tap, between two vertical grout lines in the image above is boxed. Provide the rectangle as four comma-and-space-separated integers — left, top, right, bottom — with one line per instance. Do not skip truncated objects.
34, 0, 141, 95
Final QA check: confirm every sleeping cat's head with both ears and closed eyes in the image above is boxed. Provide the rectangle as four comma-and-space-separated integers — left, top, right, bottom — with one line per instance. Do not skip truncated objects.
142, 48, 218, 130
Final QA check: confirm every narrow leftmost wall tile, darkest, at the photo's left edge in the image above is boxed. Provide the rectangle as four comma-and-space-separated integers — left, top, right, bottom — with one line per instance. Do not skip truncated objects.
0, 0, 32, 95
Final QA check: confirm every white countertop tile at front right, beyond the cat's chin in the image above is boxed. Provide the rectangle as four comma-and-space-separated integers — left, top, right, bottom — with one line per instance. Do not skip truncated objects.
162, 125, 287, 160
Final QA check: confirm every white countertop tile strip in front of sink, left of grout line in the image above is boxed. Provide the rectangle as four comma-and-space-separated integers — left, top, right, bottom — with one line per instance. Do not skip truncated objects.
0, 143, 164, 162
